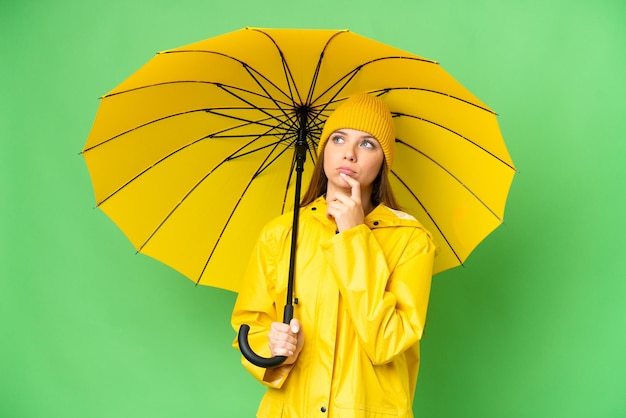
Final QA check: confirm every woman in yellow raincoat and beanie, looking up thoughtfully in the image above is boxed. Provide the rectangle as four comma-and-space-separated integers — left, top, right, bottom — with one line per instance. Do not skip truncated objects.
232, 94, 435, 418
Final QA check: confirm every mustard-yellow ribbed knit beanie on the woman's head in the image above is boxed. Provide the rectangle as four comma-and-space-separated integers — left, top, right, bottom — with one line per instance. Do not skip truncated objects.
317, 93, 396, 170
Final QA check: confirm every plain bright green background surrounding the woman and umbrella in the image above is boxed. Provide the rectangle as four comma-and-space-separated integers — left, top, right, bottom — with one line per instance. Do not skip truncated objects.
0, 0, 626, 418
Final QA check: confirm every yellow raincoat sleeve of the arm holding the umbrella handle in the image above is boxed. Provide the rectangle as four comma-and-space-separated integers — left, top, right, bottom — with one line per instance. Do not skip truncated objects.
231, 222, 294, 388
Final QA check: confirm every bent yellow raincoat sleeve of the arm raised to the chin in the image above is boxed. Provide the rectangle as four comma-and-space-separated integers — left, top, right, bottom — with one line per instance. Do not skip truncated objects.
322, 225, 435, 365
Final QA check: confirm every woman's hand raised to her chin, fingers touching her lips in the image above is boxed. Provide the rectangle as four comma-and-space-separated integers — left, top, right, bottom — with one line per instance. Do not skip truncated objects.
326, 174, 365, 232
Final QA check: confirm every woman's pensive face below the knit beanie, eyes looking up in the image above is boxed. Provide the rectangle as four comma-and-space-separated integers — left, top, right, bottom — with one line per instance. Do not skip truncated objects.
324, 129, 384, 191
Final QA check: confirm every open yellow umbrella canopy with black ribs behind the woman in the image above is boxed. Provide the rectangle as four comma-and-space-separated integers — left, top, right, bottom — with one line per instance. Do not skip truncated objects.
83, 28, 515, 291
